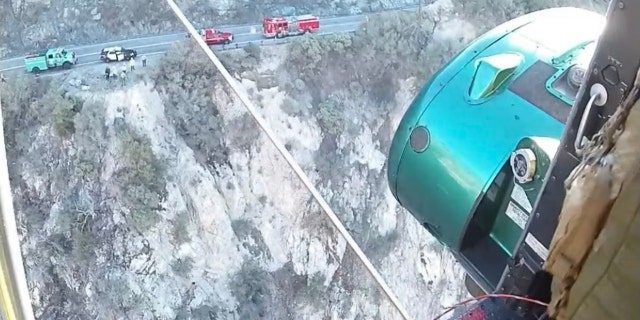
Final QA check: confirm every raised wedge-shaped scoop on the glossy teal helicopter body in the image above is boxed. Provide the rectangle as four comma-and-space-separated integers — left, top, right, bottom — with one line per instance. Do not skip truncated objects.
468, 53, 524, 101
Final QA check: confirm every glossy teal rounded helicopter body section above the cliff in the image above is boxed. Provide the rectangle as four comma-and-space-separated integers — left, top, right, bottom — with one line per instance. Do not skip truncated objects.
388, 8, 605, 291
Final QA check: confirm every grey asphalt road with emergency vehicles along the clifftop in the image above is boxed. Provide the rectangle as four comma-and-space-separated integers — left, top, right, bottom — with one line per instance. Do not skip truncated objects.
0, 7, 416, 74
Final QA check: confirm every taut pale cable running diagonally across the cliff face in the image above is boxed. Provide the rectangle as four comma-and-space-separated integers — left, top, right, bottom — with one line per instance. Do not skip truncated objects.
167, 0, 411, 320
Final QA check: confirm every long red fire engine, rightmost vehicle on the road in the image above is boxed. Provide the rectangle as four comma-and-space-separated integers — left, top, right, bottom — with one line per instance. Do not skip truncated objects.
262, 14, 320, 38
